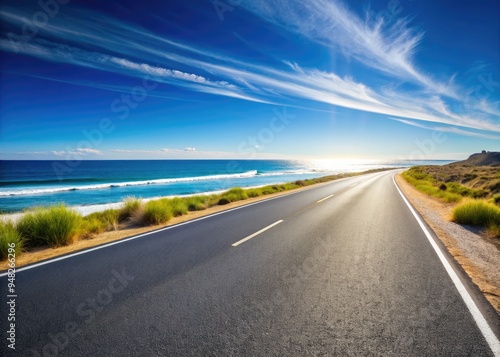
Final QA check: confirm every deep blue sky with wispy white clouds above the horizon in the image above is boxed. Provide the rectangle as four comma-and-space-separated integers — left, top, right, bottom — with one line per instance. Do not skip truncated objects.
0, 0, 500, 160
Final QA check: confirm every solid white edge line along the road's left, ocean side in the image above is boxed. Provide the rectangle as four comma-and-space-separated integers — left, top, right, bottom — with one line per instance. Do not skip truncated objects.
0, 174, 386, 278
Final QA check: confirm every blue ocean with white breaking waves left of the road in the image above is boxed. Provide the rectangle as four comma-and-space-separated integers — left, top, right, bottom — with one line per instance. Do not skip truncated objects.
0, 160, 450, 213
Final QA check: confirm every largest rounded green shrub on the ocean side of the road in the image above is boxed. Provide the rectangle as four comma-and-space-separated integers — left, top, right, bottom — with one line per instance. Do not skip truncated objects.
17, 205, 82, 247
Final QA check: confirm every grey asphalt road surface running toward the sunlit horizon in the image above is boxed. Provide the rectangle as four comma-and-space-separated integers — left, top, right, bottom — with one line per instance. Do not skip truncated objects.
0, 172, 499, 357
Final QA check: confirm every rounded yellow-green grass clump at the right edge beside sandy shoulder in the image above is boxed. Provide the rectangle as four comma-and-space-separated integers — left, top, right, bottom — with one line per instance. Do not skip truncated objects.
452, 200, 500, 237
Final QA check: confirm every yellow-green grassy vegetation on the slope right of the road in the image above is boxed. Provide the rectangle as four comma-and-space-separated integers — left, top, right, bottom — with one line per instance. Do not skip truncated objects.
402, 166, 500, 238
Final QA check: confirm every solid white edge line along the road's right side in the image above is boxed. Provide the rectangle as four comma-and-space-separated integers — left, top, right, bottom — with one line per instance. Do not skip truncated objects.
392, 175, 500, 357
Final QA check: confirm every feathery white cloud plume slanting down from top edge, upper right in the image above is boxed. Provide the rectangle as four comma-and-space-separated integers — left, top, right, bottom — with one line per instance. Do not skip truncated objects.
240, 0, 456, 97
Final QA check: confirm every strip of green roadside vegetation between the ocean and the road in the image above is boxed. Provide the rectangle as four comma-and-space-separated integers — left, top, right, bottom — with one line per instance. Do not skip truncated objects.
0, 169, 387, 260
